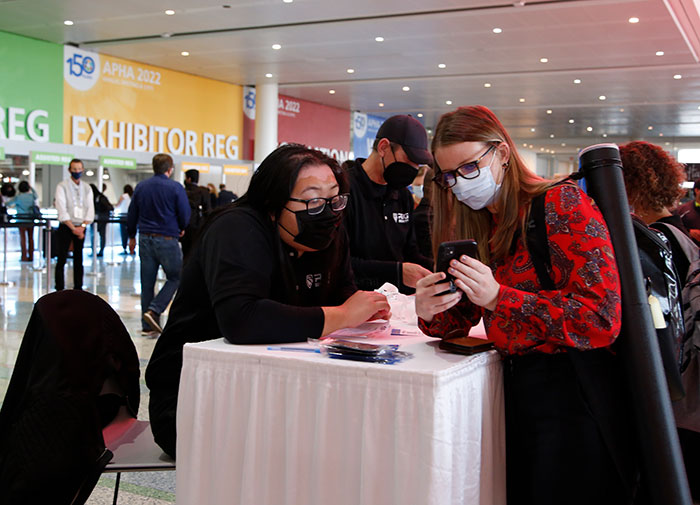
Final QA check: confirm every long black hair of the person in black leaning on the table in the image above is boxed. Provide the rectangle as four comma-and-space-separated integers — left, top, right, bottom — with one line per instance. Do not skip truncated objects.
234, 144, 348, 219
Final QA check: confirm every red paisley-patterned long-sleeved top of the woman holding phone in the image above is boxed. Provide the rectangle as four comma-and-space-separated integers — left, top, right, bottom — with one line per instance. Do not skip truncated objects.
418, 184, 621, 355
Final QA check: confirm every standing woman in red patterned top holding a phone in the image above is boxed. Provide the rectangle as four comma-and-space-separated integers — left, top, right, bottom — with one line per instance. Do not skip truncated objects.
416, 106, 633, 505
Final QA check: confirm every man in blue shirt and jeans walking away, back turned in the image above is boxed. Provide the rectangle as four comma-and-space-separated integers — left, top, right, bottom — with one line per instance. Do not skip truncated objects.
127, 154, 190, 336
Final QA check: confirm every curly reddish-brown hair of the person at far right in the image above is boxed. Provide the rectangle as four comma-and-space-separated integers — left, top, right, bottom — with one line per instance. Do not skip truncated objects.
620, 141, 686, 212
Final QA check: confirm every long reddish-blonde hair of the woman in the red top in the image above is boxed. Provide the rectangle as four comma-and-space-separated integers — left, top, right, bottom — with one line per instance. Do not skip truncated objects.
431, 105, 552, 264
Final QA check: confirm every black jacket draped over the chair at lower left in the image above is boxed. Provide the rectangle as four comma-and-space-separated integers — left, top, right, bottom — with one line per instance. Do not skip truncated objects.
0, 290, 140, 505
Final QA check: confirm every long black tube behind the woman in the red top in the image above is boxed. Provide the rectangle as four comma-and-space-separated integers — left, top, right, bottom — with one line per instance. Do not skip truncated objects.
579, 144, 692, 505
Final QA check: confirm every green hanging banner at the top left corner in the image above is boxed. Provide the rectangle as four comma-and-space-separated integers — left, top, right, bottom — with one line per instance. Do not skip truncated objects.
0, 32, 63, 143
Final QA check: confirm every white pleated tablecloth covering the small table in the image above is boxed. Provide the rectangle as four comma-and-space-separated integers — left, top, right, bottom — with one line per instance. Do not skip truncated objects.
177, 336, 505, 505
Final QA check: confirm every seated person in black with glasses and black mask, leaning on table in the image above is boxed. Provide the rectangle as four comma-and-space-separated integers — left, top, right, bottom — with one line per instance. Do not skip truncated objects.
146, 144, 390, 457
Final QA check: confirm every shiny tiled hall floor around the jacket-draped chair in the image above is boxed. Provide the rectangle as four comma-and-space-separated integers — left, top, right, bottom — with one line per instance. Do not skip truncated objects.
0, 247, 175, 505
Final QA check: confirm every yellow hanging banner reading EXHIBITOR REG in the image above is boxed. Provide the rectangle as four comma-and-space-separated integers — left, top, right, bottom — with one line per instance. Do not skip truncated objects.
63, 46, 243, 160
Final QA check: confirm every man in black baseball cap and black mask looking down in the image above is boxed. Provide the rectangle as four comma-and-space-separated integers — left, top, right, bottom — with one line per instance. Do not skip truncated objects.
344, 115, 433, 293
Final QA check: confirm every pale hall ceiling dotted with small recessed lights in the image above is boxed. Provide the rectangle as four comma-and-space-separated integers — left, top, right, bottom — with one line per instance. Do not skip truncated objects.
0, 0, 700, 154
